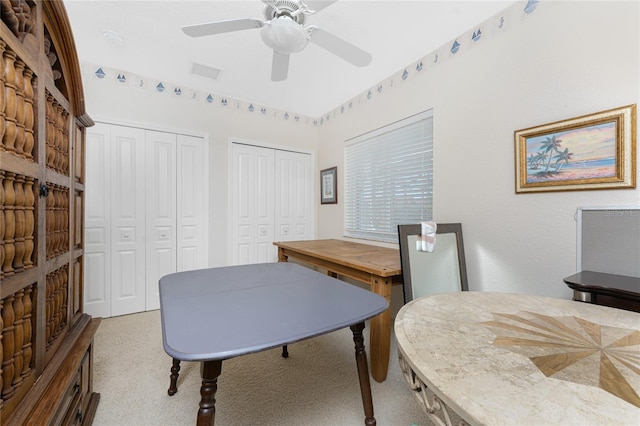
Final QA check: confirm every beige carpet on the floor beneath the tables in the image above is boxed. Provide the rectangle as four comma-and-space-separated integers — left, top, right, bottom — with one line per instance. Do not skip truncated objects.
94, 311, 431, 426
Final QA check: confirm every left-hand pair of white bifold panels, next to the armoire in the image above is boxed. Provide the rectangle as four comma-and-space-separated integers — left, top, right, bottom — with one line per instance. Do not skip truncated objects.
84, 123, 146, 318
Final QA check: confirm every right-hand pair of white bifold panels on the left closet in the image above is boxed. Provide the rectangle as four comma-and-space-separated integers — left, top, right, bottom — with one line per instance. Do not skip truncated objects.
146, 130, 208, 311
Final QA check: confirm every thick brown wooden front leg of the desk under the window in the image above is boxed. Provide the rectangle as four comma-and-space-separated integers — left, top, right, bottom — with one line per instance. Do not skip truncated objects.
369, 276, 392, 383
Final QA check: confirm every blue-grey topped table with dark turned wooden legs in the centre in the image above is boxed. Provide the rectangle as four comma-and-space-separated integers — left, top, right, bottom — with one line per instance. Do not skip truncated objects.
159, 263, 388, 426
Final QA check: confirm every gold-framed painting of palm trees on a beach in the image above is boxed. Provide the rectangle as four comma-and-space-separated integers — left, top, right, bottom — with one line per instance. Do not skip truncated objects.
514, 104, 636, 193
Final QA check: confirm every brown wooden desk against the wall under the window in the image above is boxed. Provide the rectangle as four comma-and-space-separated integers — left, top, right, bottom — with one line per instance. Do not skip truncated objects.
273, 240, 402, 382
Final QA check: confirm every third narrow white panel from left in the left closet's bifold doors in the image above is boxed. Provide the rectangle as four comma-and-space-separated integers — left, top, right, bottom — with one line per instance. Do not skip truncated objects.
145, 130, 176, 311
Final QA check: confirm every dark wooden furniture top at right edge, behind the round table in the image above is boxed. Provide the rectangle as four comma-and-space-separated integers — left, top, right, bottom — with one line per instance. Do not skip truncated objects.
563, 271, 640, 312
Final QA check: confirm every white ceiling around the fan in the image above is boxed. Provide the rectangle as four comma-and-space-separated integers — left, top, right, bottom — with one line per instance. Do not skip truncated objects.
64, 0, 514, 117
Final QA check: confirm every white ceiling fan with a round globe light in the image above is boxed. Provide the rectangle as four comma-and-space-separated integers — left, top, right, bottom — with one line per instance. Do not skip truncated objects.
182, 0, 371, 81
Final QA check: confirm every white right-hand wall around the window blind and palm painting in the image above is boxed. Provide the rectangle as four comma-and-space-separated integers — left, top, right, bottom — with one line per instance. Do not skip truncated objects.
317, 1, 640, 298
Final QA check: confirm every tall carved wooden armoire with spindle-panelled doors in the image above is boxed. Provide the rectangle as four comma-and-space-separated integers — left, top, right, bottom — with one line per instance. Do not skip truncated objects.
0, 0, 100, 425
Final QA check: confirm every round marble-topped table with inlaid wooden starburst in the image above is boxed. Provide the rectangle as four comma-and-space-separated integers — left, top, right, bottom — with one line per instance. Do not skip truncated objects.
395, 292, 640, 425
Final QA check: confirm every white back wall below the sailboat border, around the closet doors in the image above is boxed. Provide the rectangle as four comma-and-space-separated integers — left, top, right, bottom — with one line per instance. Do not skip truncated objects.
82, 71, 317, 266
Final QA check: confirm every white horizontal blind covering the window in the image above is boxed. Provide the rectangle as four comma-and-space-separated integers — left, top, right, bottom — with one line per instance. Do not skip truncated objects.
344, 111, 433, 242
